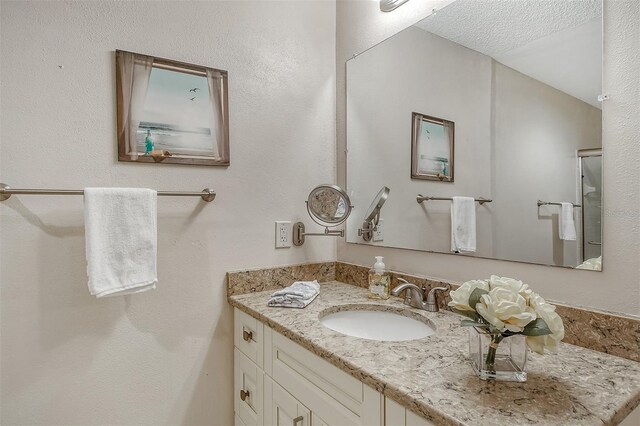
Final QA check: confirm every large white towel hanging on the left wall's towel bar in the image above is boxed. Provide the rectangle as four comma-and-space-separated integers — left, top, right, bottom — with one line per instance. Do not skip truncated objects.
84, 188, 158, 297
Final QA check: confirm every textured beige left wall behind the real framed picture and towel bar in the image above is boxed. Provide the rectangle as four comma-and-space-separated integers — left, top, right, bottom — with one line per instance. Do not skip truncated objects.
0, 1, 336, 425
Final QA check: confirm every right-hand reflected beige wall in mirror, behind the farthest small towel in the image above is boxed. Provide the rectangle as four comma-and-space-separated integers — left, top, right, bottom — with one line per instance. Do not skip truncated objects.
491, 62, 609, 267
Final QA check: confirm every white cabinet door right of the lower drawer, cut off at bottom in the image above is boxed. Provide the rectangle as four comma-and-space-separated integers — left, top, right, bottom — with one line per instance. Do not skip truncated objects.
264, 376, 311, 426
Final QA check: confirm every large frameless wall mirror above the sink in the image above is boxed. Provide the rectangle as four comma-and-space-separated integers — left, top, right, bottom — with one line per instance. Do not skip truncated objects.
347, 0, 603, 270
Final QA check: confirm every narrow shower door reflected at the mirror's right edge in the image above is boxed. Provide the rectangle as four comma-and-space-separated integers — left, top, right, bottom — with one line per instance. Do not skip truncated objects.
578, 149, 602, 261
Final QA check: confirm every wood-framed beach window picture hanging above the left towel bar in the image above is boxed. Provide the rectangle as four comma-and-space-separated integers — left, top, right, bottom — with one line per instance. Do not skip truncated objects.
116, 50, 229, 166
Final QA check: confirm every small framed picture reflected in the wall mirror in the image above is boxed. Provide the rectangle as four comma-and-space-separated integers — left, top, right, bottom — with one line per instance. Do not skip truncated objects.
411, 112, 455, 182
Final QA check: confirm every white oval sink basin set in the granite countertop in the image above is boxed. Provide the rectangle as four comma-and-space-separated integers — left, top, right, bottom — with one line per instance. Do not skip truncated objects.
320, 311, 435, 342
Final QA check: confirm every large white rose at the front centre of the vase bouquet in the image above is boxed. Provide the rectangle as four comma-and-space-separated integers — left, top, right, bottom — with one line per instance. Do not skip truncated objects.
476, 286, 536, 333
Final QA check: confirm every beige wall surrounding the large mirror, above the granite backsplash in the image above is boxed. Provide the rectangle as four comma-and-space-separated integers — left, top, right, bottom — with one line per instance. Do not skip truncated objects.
336, 0, 640, 315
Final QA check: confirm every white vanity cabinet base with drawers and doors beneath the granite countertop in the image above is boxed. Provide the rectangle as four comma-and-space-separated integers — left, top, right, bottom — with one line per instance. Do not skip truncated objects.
234, 309, 418, 426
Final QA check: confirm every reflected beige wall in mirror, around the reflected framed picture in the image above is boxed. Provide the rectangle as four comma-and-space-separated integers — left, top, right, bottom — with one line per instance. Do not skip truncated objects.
347, 27, 493, 257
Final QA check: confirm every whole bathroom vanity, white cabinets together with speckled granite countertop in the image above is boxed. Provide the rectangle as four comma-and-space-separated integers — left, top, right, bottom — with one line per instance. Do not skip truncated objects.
229, 281, 640, 426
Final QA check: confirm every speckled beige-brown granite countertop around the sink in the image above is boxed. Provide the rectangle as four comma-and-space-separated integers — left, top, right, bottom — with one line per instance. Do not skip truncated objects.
229, 281, 640, 425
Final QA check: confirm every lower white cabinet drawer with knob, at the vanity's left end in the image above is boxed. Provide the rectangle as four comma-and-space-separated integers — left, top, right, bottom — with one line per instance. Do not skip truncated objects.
233, 348, 264, 426
